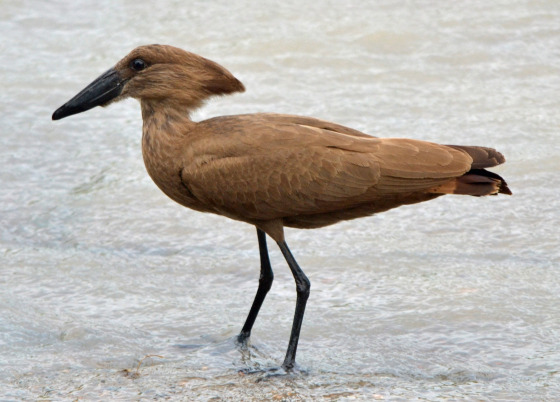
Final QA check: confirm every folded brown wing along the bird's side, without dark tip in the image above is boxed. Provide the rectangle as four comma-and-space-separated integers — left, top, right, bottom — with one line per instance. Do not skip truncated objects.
181, 115, 472, 220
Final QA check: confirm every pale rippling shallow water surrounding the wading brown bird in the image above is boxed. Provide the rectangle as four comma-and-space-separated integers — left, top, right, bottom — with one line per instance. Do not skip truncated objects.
0, 0, 560, 400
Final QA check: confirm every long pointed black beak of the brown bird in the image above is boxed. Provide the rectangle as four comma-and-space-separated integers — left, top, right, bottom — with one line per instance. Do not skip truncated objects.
52, 68, 128, 120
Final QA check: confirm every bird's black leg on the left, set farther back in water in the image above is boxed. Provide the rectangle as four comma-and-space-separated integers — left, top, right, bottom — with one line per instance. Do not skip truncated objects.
237, 228, 274, 345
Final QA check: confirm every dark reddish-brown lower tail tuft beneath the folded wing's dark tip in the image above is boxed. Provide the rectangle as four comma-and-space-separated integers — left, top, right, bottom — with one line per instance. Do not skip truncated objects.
430, 169, 511, 197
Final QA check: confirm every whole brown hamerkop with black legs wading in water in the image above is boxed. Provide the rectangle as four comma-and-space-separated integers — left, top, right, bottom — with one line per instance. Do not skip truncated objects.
52, 45, 511, 370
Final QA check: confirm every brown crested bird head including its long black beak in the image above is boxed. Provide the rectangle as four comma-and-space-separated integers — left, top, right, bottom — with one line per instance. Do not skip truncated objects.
52, 45, 245, 120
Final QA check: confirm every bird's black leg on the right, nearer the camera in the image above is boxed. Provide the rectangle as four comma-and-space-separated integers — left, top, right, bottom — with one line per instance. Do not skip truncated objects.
278, 241, 311, 371
